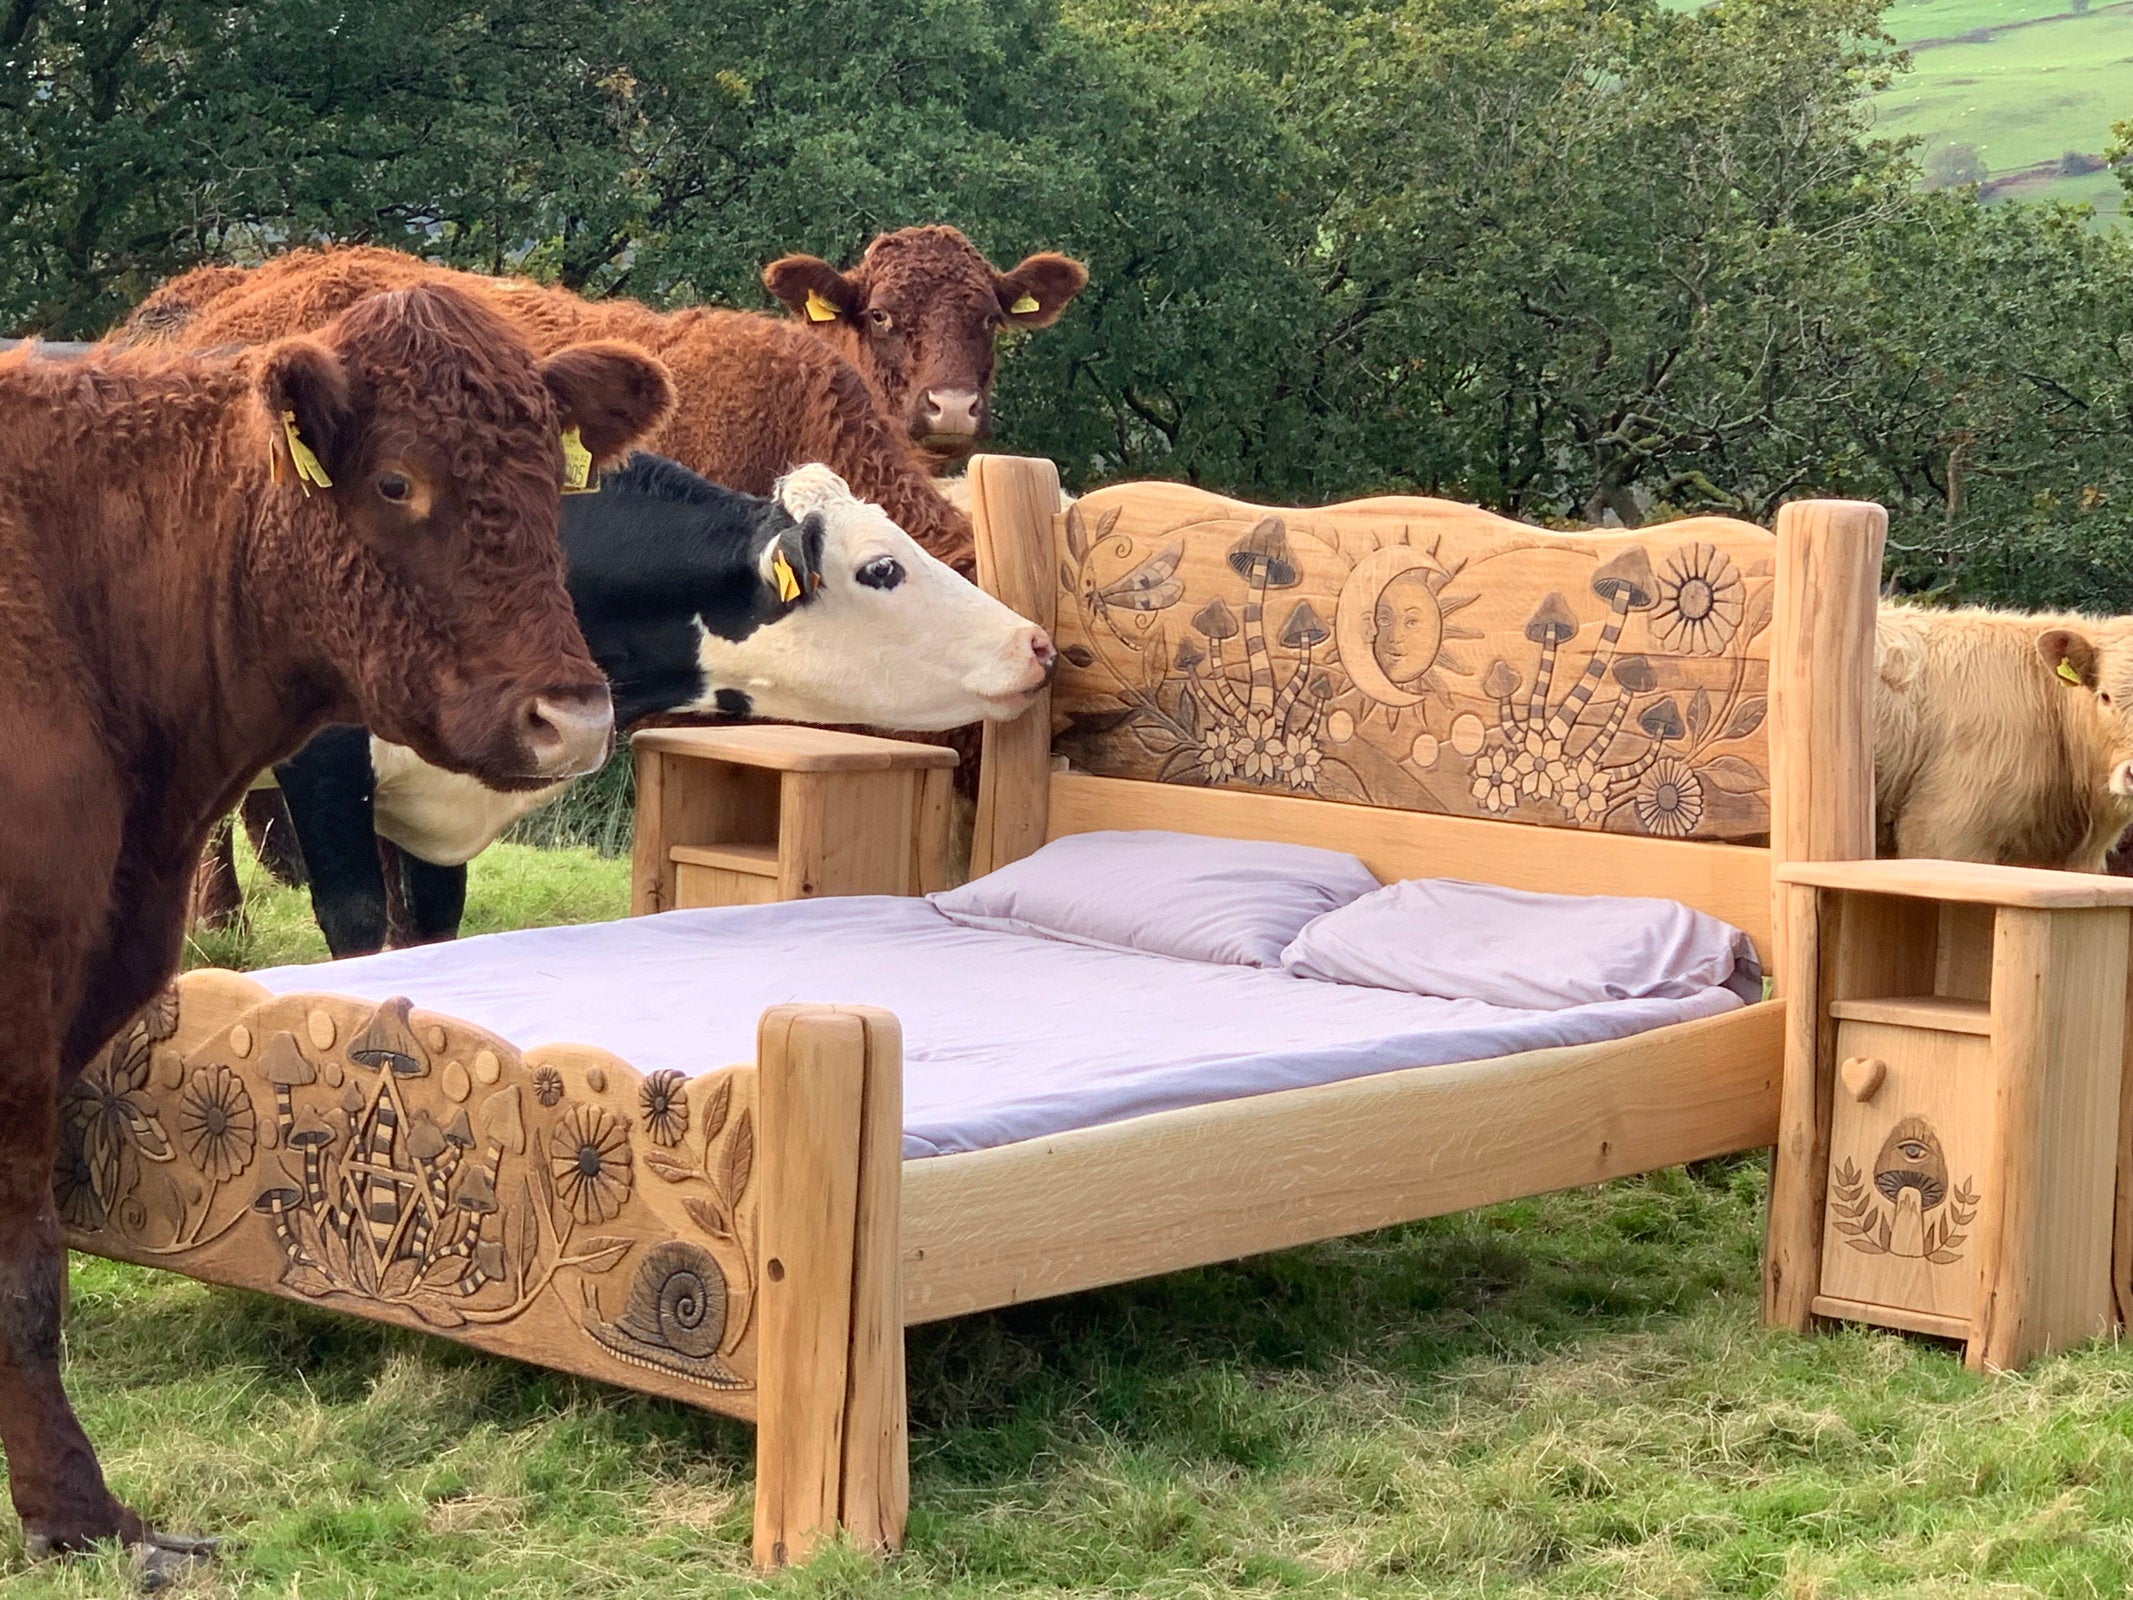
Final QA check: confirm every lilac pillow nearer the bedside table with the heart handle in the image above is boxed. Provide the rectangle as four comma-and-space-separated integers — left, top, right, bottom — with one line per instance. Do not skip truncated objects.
1282, 879, 1762, 1011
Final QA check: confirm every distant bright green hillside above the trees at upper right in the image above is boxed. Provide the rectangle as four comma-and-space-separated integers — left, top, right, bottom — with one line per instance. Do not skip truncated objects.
1679, 0, 2133, 213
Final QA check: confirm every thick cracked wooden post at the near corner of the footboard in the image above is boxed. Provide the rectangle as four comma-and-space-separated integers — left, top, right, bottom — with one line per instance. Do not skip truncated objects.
755, 1005, 911, 1568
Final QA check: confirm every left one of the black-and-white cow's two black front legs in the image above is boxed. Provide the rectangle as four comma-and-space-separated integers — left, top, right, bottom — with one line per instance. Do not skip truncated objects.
275, 727, 386, 956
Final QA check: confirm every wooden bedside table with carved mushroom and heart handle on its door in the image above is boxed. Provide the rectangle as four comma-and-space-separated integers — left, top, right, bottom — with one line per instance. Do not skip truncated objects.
1764, 862, 2133, 1370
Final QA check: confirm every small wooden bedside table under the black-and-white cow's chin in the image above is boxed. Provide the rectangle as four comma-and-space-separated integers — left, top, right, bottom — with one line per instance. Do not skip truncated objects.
629, 725, 956, 915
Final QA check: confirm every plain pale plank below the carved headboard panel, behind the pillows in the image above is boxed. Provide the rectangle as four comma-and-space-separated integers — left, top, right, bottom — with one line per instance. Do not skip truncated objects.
1045, 772, 1770, 951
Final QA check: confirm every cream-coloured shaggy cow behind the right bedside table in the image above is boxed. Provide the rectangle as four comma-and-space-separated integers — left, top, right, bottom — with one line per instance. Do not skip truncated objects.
1875, 604, 2133, 873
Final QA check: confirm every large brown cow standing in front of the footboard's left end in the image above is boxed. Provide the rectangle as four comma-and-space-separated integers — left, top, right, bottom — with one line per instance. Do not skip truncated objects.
0, 288, 672, 1581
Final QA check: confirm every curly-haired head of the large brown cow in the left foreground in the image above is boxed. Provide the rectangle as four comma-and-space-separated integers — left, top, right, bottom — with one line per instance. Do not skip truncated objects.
256, 286, 674, 789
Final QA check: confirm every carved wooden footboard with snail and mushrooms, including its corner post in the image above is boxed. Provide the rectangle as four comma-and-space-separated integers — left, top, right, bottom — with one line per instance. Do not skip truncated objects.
55, 971, 904, 1564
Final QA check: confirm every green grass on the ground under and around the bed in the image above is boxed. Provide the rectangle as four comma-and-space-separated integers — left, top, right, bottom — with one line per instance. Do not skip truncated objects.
12, 847, 2133, 1600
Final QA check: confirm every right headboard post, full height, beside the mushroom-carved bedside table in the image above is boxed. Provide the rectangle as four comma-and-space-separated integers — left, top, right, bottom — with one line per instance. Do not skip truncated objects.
1762, 499, 1888, 1333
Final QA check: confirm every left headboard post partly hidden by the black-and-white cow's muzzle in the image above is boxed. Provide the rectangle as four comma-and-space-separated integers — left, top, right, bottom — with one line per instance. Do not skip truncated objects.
971, 457, 1060, 877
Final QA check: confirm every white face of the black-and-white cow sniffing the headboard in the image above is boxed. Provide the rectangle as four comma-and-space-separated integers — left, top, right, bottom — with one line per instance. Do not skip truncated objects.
700, 465, 1054, 732
